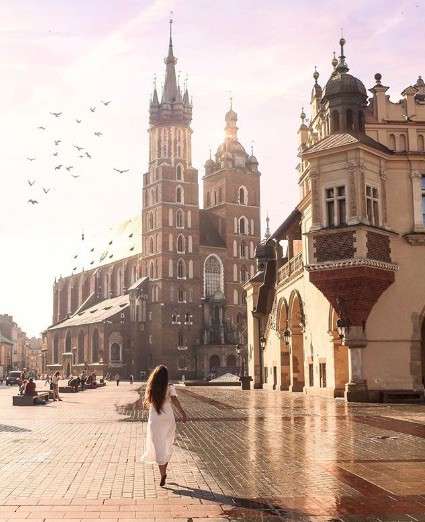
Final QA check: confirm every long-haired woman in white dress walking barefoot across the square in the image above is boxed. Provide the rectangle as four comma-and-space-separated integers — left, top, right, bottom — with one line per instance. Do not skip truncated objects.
142, 364, 187, 486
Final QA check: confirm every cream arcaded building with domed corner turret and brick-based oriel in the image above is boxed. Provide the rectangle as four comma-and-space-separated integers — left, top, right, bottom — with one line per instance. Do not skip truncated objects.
245, 39, 425, 401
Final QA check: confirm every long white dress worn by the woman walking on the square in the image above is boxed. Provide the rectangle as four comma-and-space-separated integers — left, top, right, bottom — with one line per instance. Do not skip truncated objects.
141, 384, 177, 465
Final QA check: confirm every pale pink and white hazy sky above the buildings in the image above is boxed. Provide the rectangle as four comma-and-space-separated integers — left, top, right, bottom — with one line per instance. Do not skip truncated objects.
0, 0, 425, 336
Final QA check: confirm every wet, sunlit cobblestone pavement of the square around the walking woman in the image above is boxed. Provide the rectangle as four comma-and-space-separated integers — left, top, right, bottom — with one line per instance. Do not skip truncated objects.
0, 382, 425, 522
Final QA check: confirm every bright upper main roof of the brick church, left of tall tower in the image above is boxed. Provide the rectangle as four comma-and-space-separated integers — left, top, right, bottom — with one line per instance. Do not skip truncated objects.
67, 214, 142, 274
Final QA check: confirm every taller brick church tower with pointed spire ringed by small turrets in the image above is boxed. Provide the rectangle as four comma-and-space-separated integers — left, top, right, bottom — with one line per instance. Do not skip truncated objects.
142, 20, 201, 379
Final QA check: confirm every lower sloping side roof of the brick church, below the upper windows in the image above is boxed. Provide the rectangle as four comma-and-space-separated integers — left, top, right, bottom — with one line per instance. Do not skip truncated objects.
48, 294, 130, 331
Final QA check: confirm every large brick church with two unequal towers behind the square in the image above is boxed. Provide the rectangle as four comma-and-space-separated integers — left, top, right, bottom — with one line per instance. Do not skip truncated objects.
43, 25, 260, 379
